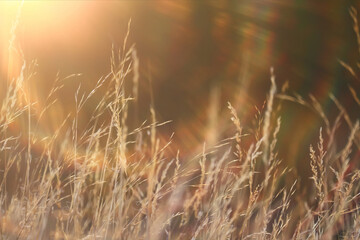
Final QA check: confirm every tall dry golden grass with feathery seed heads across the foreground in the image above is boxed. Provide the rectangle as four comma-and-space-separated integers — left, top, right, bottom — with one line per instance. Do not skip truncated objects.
0, 1, 360, 239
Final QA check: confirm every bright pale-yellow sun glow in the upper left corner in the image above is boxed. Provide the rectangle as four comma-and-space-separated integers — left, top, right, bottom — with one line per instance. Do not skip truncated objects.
0, 1, 92, 80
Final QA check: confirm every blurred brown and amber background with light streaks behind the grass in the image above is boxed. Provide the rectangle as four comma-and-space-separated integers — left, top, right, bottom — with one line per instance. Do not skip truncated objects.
0, 0, 360, 186
